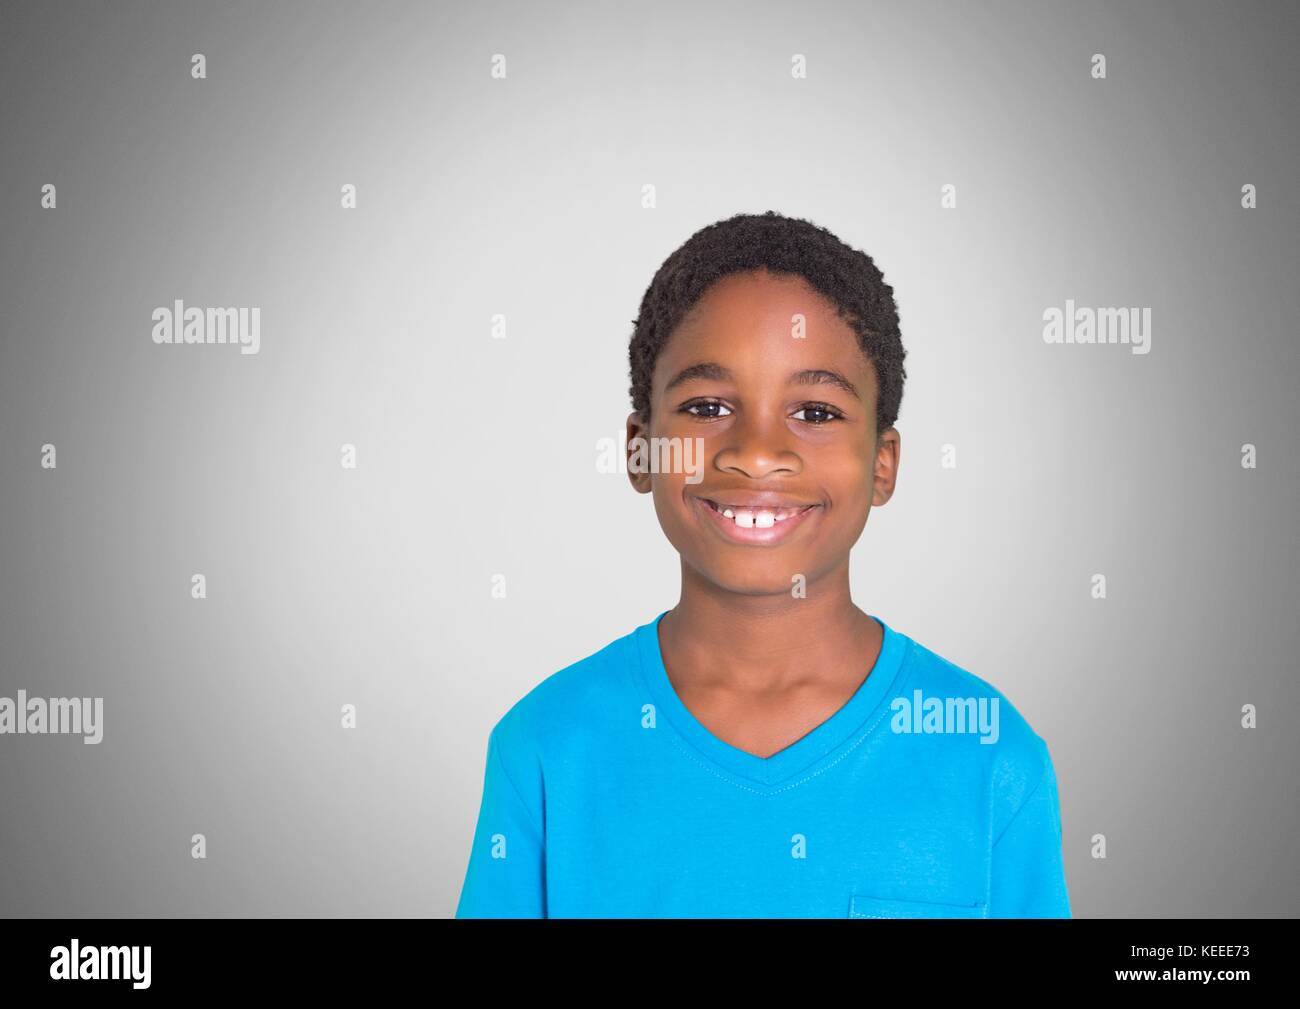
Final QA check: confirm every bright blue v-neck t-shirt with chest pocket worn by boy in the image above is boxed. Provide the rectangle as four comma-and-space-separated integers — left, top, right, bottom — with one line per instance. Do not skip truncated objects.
456, 614, 1070, 918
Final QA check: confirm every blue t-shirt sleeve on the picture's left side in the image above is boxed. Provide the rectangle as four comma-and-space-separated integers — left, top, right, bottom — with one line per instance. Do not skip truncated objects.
456, 726, 546, 918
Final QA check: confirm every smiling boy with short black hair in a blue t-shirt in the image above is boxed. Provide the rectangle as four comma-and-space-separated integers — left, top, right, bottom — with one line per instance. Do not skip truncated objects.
456, 211, 1070, 918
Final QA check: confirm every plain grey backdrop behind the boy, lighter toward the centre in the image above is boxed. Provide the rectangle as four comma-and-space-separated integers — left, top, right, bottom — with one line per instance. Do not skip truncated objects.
0, 0, 1300, 917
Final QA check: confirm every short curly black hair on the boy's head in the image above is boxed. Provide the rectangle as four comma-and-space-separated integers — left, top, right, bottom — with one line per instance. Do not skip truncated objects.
628, 211, 907, 432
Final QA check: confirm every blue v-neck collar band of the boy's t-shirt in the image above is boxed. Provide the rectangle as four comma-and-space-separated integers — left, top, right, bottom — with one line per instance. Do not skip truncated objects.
633, 610, 911, 791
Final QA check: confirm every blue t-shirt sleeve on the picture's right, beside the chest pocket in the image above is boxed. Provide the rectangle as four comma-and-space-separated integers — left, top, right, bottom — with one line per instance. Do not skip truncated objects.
989, 739, 1070, 918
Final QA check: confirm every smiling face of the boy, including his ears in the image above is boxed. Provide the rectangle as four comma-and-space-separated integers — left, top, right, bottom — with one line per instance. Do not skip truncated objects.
628, 270, 900, 596
